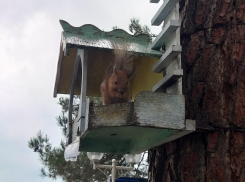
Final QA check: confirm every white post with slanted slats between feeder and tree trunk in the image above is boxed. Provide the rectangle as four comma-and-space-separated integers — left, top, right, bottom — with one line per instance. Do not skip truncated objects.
150, 0, 183, 94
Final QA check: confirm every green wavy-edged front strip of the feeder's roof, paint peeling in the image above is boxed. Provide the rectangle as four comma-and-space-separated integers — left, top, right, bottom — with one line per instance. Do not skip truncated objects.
60, 20, 162, 58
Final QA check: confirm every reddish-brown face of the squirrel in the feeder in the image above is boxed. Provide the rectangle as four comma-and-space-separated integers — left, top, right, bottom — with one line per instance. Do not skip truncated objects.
111, 69, 129, 97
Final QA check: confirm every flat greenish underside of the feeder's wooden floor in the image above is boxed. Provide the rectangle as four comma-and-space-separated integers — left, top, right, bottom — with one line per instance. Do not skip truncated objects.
80, 120, 196, 154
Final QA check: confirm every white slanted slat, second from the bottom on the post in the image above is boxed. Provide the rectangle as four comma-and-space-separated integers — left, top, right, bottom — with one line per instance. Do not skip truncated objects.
152, 45, 182, 73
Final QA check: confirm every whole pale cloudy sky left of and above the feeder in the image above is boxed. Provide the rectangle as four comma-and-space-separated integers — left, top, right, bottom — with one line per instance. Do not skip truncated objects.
0, 0, 161, 182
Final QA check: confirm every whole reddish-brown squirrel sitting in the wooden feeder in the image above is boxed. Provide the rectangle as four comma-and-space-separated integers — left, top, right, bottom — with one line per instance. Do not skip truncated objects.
100, 43, 135, 105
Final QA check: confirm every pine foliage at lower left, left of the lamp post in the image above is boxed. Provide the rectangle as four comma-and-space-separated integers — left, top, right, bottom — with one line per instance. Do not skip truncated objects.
28, 131, 106, 182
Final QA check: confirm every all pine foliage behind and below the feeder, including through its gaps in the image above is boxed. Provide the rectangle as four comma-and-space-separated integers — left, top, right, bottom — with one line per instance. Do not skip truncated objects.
28, 97, 147, 182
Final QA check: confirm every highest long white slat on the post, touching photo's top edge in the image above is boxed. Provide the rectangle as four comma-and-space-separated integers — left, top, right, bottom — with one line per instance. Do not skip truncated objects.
151, 0, 178, 26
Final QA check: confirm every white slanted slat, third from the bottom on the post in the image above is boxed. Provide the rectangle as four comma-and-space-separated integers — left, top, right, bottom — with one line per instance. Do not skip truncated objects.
151, 20, 179, 50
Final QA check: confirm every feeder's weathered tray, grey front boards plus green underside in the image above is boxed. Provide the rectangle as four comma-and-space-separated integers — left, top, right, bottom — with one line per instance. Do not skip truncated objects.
75, 92, 195, 153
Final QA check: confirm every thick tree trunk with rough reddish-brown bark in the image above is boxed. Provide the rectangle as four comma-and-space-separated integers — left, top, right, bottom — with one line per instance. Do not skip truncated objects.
149, 0, 245, 182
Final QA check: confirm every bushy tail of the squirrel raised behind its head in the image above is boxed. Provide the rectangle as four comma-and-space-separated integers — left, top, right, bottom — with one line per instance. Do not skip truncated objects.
108, 42, 135, 78
